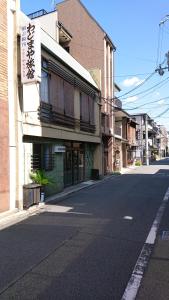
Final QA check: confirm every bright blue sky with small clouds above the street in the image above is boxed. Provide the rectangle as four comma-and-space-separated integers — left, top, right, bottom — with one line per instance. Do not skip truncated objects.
21, 0, 169, 130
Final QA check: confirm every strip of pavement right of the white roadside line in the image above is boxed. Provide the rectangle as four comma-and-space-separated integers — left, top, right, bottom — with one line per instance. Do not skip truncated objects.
136, 198, 169, 300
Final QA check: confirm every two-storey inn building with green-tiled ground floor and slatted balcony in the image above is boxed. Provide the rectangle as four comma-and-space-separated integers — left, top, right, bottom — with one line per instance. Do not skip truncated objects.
18, 11, 102, 204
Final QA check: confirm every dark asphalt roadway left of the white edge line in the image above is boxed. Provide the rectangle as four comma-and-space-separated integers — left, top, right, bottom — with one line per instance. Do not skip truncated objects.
0, 159, 169, 300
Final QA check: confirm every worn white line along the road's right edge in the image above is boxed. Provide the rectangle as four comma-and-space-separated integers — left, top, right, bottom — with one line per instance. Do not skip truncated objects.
121, 188, 169, 300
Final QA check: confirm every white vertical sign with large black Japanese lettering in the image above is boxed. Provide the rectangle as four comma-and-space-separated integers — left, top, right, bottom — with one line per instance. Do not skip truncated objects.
21, 20, 41, 83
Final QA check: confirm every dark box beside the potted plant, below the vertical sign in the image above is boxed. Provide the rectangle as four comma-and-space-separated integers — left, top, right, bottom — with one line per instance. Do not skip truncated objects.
23, 183, 41, 209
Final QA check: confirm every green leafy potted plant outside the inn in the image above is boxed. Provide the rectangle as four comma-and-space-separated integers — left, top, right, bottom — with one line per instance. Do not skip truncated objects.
30, 170, 53, 202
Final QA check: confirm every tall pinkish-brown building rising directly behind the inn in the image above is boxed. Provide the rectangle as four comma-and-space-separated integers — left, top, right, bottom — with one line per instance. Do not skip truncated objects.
56, 0, 116, 174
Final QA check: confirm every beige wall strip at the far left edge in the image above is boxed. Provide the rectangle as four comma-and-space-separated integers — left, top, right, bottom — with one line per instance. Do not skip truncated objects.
0, 0, 9, 212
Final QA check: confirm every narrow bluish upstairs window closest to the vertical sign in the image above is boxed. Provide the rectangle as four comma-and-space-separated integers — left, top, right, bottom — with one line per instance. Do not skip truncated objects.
40, 59, 49, 103
